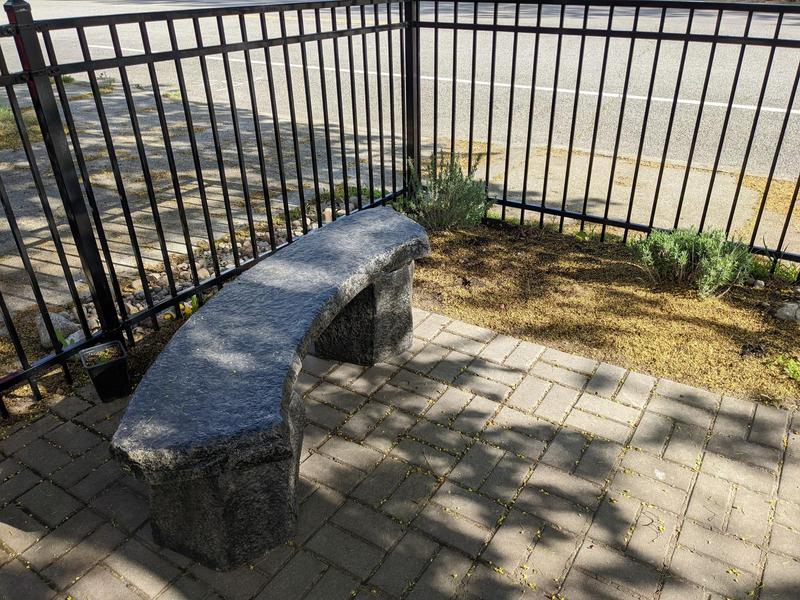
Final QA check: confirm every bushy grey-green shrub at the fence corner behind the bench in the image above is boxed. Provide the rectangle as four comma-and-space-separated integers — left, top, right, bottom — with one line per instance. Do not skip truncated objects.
394, 153, 491, 231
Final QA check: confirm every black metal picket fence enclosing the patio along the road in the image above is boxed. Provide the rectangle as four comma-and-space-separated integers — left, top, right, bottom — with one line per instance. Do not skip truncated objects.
0, 0, 800, 404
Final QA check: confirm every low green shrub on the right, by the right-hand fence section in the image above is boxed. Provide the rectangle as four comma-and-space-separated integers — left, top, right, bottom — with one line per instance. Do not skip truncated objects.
631, 229, 753, 298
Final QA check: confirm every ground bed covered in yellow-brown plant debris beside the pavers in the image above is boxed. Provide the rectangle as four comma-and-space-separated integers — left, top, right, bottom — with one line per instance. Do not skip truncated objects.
415, 225, 800, 406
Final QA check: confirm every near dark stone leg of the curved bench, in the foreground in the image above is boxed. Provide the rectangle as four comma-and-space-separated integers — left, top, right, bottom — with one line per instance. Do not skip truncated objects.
145, 393, 304, 570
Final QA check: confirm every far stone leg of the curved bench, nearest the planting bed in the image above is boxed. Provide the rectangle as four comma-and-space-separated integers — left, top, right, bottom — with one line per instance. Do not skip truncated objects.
314, 262, 414, 365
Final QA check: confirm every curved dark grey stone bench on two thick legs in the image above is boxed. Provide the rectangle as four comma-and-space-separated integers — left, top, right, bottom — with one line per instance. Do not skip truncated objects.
111, 207, 429, 569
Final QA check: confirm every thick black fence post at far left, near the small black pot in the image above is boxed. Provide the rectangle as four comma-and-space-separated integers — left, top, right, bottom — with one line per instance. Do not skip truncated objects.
4, 0, 119, 331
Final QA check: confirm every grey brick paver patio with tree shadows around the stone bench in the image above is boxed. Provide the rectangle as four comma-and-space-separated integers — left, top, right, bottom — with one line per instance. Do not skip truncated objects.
0, 311, 800, 600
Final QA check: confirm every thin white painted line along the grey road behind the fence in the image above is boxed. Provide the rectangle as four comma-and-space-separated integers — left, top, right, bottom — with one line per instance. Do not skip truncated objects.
89, 44, 800, 115
